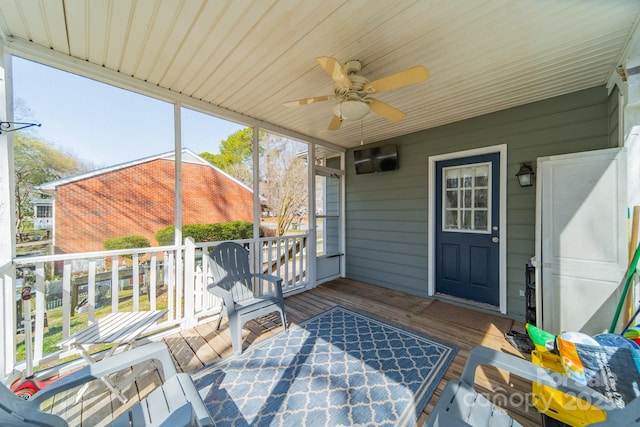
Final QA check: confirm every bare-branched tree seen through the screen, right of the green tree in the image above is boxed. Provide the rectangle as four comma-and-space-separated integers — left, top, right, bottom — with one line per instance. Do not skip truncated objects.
260, 135, 308, 236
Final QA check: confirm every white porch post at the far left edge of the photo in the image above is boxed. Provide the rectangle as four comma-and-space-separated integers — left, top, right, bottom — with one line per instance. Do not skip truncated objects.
0, 43, 16, 378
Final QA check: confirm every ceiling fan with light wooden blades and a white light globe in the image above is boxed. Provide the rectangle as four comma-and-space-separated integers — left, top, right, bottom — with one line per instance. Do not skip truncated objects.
283, 56, 429, 130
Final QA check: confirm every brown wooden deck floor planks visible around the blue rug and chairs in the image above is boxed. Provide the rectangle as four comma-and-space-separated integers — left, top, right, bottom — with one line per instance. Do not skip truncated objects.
53, 279, 541, 426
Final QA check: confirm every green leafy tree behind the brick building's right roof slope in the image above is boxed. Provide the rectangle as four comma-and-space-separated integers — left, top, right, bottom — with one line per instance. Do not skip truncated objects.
200, 128, 264, 187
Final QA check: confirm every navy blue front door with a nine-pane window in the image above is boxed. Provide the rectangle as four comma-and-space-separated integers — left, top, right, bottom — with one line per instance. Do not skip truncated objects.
435, 153, 500, 306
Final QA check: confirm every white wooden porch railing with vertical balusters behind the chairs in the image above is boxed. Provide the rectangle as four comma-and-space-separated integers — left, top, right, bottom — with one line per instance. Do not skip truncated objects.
6, 234, 309, 374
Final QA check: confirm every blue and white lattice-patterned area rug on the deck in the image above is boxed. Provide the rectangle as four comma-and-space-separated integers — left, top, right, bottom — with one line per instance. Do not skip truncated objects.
193, 307, 457, 426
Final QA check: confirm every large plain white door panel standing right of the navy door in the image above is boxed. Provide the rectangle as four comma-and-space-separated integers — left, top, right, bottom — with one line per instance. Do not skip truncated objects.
536, 148, 627, 334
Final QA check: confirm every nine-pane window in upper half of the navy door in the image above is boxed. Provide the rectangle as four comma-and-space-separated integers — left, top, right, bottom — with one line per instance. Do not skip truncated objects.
442, 163, 491, 233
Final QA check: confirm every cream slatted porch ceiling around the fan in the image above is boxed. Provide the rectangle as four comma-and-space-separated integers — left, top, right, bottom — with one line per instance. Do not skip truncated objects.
0, 0, 640, 147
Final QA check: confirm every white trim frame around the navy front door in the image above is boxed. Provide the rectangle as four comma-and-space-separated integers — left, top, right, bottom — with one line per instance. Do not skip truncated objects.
427, 144, 507, 314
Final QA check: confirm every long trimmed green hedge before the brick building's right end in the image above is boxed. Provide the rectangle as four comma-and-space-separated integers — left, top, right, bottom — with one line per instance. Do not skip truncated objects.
156, 221, 253, 246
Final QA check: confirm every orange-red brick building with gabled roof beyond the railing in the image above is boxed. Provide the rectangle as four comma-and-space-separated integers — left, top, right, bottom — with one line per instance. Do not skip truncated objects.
40, 149, 253, 253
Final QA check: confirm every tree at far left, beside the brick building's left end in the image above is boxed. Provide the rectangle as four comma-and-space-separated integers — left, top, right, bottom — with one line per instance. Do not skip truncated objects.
13, 131, 89, 231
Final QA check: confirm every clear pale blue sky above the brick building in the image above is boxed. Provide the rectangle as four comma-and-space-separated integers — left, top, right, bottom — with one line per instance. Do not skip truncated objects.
13, 57, 244, 167
